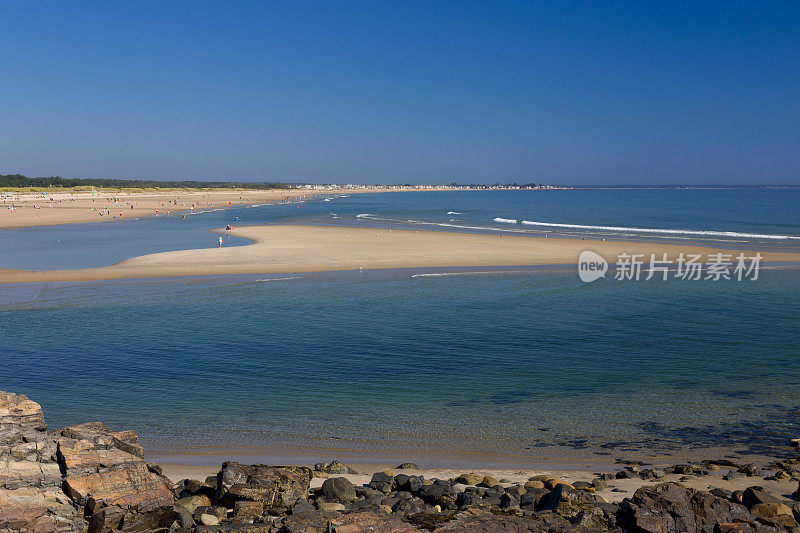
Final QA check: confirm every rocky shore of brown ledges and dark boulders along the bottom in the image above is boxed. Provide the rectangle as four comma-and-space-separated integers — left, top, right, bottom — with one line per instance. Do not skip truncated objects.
0, 391, 800, 533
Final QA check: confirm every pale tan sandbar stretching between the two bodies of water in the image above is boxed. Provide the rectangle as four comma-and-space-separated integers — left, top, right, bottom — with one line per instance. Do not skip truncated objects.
0, 225, 800, 283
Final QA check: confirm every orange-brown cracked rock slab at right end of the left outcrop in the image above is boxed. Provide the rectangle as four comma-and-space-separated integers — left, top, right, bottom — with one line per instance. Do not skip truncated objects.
64, 462, 175, 512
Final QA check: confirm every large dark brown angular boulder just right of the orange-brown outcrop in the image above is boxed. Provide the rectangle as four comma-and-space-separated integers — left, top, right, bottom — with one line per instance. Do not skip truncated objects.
215, 461, 312, 512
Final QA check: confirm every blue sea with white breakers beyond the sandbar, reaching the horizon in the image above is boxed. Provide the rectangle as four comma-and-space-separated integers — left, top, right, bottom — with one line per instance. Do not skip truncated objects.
0, 189, 800, 269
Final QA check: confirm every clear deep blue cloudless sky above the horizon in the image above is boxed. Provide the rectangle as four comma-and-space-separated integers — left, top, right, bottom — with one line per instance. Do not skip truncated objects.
0, 0, 800, 184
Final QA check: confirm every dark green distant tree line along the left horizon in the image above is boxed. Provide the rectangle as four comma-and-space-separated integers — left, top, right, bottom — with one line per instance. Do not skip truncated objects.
0, 174, 289, 189
